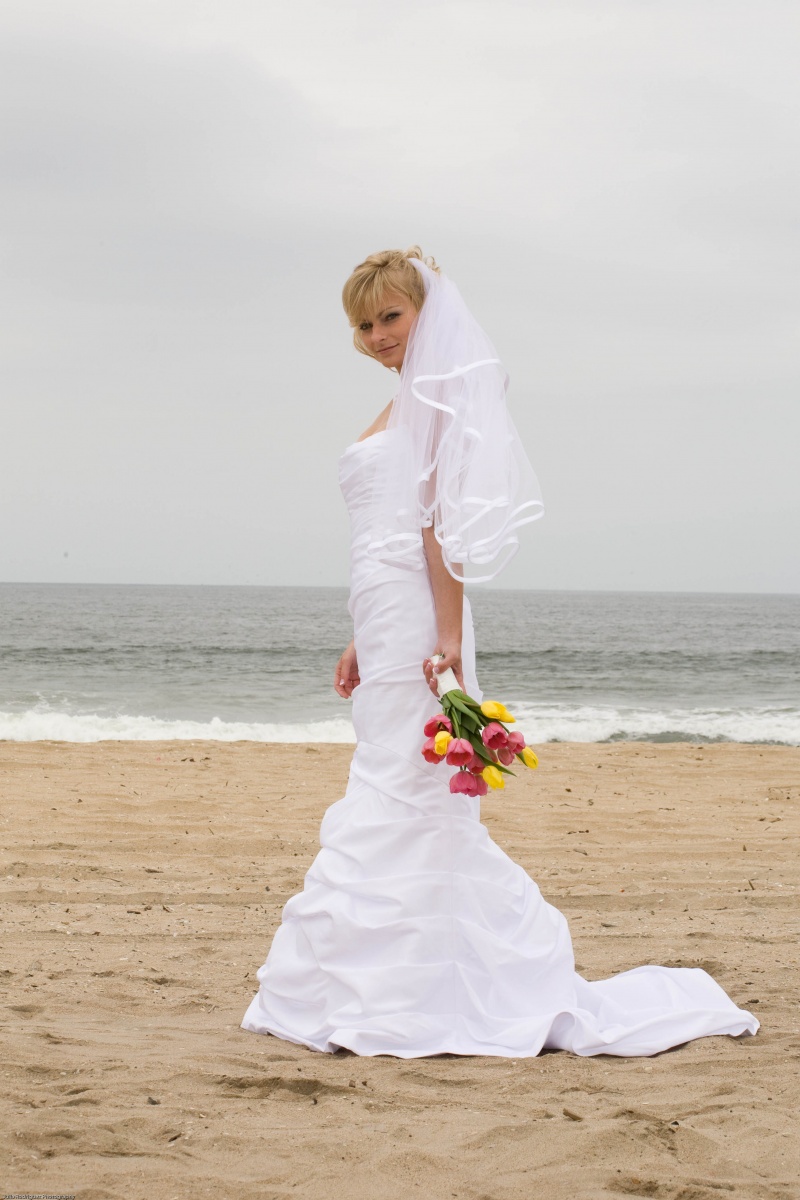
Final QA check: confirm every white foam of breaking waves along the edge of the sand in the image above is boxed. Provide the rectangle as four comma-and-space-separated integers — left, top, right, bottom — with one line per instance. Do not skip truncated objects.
0, 702, 800, 745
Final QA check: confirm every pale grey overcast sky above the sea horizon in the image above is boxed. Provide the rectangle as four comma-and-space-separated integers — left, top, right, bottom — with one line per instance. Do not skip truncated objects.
0, 0, 800, 592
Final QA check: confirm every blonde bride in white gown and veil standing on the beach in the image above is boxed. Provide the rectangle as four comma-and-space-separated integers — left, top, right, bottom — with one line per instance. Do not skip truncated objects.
242, 246, 758, 1058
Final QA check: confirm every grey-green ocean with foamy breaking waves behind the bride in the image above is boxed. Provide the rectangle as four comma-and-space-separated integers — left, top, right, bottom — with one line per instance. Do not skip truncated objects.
0, 583, 800, 745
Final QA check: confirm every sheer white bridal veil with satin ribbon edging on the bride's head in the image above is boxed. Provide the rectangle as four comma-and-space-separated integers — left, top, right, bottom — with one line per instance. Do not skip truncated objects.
368, 258, 543, 583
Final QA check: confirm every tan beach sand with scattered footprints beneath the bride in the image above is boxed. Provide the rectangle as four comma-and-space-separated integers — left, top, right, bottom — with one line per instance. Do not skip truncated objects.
0, 742, 800, 1200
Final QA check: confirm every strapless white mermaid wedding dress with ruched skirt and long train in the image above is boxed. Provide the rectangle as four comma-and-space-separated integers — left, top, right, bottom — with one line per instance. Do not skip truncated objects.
242, 431, 758, 1058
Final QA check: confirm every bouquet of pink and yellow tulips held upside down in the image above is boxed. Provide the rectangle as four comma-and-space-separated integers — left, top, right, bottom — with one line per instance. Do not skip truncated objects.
422, 668, 539, 796
